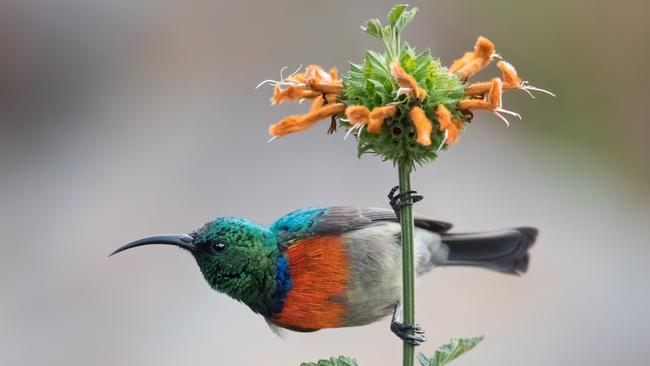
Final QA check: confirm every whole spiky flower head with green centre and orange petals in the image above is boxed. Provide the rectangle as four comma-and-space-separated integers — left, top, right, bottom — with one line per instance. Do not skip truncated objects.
260, 5, 553, 164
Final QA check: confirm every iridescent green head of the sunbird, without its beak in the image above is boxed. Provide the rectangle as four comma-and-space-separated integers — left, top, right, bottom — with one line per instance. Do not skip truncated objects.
192, 218, 278, 313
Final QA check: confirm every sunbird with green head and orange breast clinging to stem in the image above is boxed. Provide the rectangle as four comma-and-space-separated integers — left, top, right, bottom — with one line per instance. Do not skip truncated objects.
109, 206, 537, 345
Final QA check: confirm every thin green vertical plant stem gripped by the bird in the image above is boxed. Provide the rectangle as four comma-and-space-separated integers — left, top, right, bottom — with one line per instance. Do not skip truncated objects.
397, 161, 415, 366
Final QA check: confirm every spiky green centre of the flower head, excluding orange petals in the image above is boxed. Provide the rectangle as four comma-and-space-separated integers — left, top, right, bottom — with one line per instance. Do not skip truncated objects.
340, 5, 468, 169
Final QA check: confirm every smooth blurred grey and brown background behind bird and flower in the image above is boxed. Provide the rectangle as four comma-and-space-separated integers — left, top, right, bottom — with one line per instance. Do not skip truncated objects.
0, 0, 650, 366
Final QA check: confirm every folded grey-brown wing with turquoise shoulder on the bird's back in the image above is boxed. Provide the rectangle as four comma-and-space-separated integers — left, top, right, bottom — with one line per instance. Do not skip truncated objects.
270, 206, 452, 246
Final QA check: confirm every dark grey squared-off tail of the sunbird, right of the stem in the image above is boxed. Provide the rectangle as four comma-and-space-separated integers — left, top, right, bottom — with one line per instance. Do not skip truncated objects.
442, 227, 537, 274
